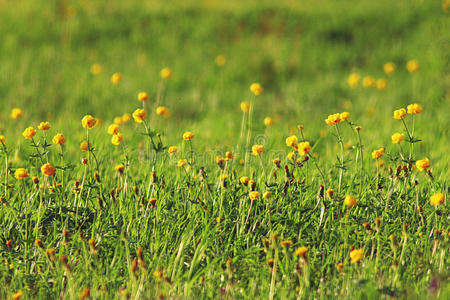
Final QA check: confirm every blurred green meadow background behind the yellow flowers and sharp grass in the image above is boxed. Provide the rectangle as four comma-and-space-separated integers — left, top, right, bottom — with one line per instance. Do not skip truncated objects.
0, 0, 450, 172
